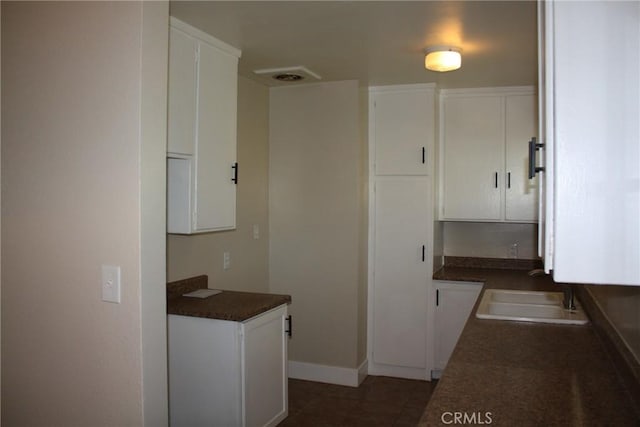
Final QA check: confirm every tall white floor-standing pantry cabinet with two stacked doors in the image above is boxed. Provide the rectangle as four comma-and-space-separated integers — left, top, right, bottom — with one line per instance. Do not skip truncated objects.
368, 84, 435, 379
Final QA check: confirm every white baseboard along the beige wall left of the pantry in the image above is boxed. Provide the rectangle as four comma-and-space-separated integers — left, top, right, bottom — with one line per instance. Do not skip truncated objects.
289, 360, 368, 387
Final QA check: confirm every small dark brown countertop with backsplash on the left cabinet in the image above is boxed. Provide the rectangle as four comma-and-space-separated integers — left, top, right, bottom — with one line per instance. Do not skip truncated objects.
167, 276, 291, 322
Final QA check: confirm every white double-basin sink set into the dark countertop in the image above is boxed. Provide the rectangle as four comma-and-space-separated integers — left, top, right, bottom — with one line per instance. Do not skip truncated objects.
476, 289, 589, 325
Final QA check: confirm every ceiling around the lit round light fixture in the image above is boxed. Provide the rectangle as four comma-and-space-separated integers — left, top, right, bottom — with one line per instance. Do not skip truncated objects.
170, 1, 537, 88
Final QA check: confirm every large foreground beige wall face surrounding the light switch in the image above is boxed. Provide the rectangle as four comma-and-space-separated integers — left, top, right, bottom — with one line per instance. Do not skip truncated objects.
2, 2, 167, 426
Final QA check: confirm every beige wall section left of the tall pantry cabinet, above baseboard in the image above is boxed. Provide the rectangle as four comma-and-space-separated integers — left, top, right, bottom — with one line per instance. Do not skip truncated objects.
269, 81, 365, 368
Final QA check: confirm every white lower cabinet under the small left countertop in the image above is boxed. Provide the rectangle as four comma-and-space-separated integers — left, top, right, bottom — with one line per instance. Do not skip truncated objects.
168, 304, 288, 427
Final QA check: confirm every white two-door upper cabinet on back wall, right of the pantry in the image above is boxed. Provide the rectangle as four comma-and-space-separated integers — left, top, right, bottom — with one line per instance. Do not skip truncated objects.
439, 88, 537, 226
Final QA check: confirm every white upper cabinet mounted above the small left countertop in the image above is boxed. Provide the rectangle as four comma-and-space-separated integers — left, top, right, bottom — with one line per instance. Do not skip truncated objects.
167, 18, 240, 234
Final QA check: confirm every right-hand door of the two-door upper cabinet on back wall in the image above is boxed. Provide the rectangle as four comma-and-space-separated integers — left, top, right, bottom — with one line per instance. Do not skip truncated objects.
505, 94, 538, 222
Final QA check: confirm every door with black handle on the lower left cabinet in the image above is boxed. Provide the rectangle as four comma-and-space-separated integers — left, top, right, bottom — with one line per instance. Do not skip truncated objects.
243, 305, 288, 426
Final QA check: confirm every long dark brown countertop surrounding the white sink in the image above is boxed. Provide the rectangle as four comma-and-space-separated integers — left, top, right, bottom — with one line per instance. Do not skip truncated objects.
419, 267, 640, 427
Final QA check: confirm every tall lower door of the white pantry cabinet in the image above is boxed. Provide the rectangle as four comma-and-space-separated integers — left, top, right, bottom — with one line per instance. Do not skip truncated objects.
372, 177, 431, 372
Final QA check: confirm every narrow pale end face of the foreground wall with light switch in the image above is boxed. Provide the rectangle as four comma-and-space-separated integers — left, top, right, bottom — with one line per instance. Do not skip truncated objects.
139, 1, 169, 427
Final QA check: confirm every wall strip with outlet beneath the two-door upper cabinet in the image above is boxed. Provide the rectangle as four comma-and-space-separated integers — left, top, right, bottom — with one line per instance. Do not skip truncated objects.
443, 222, 538, 259
